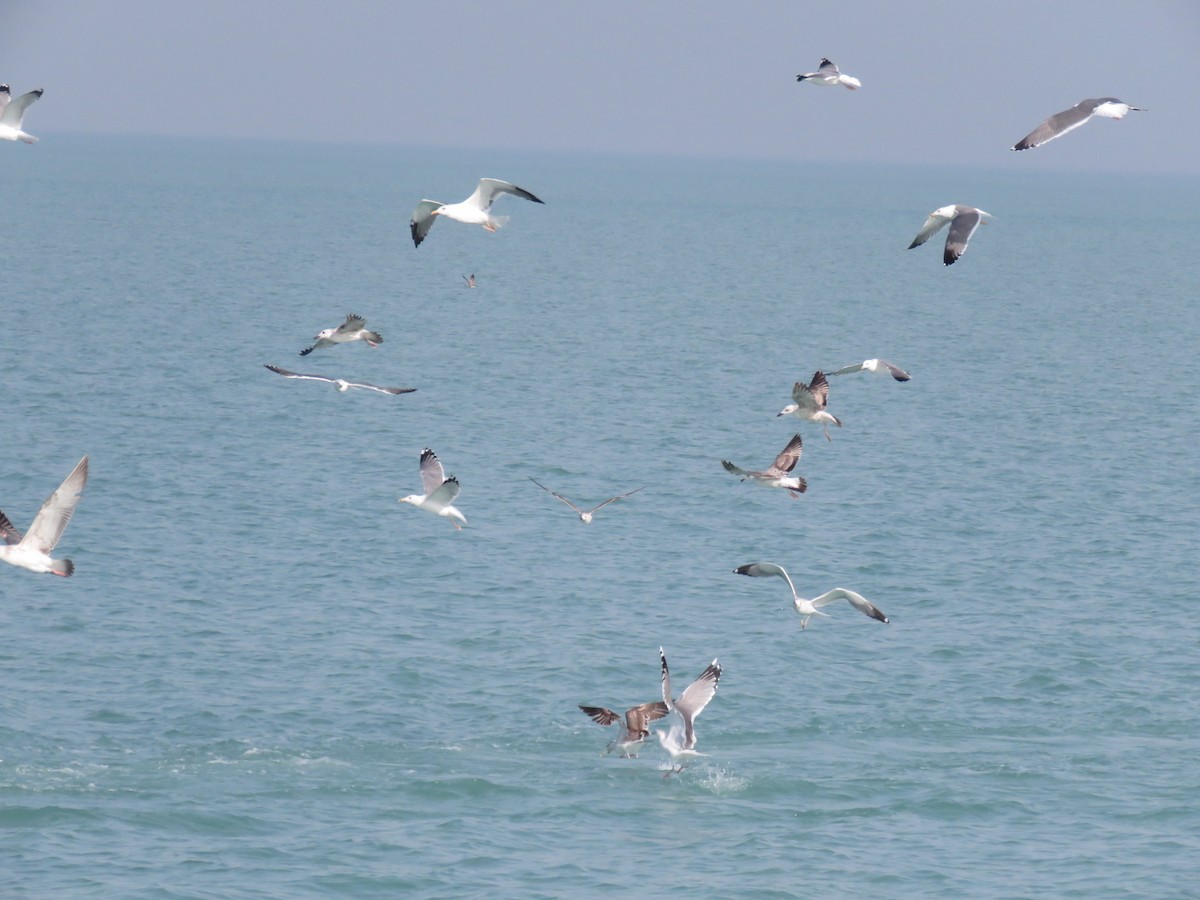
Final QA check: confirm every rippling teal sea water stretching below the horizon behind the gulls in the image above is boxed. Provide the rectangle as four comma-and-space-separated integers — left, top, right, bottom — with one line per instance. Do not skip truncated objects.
0, 137, 1200, 898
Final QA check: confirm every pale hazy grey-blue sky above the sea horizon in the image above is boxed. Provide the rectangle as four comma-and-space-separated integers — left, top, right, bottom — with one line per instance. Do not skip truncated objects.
0, 0, 1200, 174
